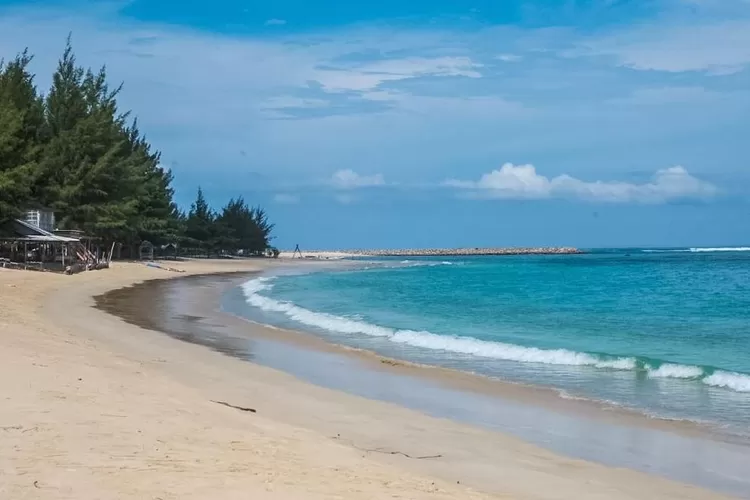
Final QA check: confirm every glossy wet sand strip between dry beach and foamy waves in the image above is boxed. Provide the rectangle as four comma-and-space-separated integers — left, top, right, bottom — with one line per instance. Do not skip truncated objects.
97, 275, 750, 495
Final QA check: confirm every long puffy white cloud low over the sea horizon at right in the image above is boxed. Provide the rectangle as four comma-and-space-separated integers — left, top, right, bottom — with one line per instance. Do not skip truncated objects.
445, 163, 718, 203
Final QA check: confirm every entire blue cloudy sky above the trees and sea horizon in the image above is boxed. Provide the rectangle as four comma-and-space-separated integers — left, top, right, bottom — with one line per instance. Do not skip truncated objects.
0, 0, 750, 250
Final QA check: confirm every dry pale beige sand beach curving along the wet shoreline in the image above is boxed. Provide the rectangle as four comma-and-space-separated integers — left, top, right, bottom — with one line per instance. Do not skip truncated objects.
0, 259, 736, 500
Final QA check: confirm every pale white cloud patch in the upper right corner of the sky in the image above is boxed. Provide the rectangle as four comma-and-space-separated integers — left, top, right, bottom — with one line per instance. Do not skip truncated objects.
568, 19, 750, 74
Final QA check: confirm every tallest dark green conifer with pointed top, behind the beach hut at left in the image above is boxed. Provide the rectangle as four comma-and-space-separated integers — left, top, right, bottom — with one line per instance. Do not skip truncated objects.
38, 39, 141, 244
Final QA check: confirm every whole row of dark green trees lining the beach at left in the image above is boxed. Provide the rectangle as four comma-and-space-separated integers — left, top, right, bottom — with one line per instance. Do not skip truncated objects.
0, 38, 273, 255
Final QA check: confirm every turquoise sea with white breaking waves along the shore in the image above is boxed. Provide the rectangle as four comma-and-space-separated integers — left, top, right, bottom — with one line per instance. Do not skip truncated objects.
243, 248, 750, 434
